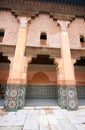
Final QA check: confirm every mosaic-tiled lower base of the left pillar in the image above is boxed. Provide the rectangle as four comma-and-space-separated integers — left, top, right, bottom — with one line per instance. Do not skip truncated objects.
4, 84, 25, 111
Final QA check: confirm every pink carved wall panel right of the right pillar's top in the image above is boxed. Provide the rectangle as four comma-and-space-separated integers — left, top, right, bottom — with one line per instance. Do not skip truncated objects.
68, 18, 85, 49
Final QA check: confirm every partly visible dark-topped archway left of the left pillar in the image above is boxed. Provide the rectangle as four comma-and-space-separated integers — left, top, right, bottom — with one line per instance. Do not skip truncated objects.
0, 52, 10, 106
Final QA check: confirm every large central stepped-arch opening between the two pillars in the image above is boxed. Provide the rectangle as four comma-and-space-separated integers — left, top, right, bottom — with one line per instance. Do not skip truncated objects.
26, 55, 58, 106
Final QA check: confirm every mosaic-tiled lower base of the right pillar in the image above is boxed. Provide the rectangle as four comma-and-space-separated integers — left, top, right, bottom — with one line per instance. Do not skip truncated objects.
58, 87, 78, 110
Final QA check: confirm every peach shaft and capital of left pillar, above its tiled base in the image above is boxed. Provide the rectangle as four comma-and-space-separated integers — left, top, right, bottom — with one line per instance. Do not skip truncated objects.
8, 17, 30, 83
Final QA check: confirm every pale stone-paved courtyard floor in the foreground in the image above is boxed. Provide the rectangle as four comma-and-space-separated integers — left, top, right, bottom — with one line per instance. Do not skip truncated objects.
0, 99, 85, 130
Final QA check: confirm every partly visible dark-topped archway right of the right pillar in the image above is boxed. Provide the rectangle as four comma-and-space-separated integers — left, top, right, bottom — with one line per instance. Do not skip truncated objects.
74, 57, 85, 105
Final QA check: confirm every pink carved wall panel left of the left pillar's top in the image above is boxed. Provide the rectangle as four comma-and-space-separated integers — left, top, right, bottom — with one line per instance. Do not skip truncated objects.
0, 10, 19, 45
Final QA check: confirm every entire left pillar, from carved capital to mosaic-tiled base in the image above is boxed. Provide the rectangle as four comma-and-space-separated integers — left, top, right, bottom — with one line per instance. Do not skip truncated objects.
5, 17, 30, 111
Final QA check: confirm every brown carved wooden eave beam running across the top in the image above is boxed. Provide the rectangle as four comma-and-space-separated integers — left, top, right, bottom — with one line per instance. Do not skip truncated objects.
0, 0, 85, 17
